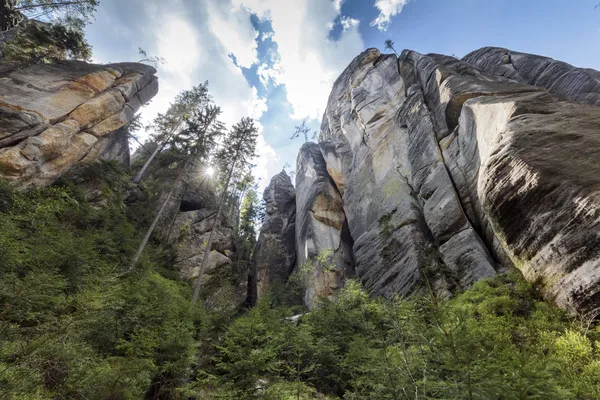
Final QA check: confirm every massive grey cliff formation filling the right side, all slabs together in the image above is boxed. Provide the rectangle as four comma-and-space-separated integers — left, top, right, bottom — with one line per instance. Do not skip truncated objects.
312, 48, 600, 312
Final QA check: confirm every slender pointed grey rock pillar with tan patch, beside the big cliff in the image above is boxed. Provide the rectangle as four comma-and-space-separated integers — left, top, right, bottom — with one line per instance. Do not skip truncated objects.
296, 143, 354, 307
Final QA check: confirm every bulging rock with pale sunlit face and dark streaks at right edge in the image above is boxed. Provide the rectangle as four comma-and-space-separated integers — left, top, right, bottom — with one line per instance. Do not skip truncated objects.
448, 94, 600, 311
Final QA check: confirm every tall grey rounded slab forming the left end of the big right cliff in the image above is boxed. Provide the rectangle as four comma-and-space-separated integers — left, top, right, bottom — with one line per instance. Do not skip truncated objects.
319, 50, 460, 297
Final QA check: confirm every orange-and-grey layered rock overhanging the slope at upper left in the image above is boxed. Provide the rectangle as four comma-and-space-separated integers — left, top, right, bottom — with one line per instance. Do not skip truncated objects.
0, 61, 158, 187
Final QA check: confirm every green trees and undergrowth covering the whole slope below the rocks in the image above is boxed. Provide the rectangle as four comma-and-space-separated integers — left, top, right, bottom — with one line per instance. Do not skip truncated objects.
0, 163, 600, 400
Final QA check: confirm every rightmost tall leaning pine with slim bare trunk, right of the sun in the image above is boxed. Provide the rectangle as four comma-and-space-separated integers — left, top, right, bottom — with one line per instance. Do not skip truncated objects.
192, 118, 258, 303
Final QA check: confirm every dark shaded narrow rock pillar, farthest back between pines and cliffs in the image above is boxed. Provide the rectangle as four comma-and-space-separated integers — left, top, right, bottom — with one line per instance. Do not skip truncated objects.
249, 171, 296, 303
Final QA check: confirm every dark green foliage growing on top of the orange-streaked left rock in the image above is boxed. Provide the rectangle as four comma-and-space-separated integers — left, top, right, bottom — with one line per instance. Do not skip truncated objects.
1, 23, 92, 66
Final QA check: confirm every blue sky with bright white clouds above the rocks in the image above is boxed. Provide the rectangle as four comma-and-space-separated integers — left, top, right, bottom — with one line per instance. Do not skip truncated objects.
87, 0, 600, 186
